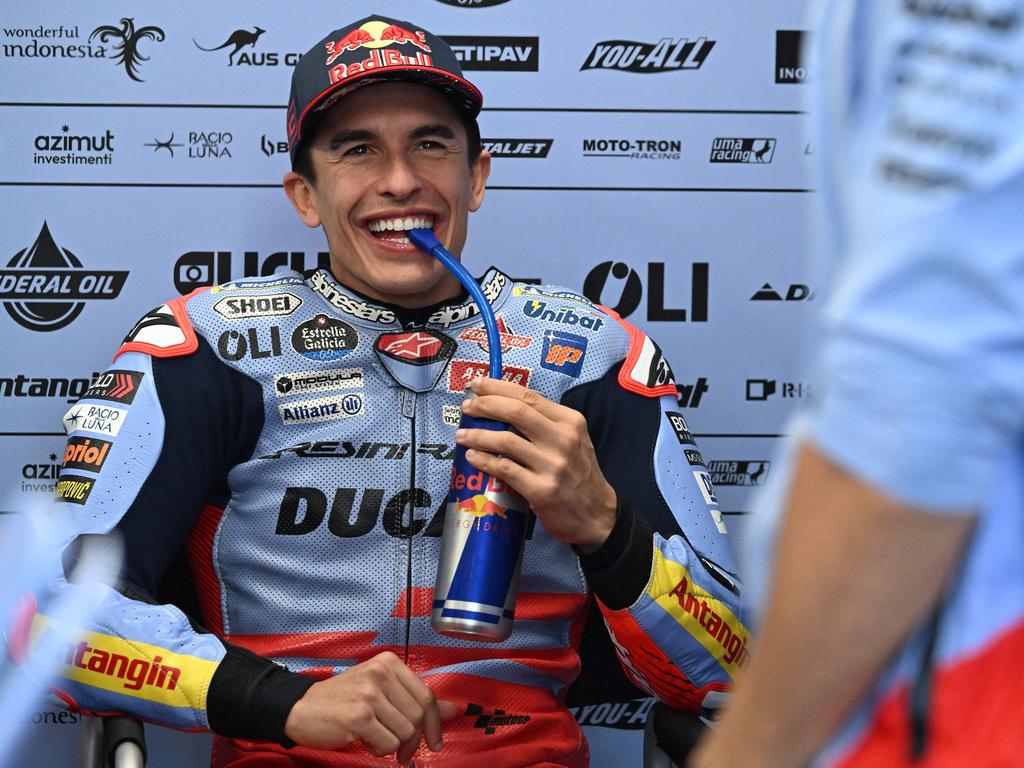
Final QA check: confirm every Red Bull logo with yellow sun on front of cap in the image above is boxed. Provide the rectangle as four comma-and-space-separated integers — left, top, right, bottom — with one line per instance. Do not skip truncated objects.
325, 22, 433, 83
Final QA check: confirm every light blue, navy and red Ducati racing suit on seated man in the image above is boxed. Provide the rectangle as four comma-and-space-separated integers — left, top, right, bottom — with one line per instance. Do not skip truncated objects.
46, 269, 749, 768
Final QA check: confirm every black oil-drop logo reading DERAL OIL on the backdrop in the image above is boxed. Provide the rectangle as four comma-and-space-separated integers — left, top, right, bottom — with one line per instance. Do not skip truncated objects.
0, 221, 128, 331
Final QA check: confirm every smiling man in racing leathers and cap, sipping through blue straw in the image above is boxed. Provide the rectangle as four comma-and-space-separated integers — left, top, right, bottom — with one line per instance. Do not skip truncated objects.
46, 16, 749, 768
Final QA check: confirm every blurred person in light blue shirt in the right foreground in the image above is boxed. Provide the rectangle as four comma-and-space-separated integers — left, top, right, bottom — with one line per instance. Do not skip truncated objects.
690, 0, 1024, 768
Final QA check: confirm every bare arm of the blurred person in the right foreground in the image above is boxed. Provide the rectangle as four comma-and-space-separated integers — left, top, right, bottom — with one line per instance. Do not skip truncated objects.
690, 447, 973, 768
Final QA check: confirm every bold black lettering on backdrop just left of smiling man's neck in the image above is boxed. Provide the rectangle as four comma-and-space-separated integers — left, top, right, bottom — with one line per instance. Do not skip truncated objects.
174, 251, 331, 296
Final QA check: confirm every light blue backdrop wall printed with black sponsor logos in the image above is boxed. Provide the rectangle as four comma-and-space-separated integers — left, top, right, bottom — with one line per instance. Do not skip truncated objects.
0, 0, 815, 767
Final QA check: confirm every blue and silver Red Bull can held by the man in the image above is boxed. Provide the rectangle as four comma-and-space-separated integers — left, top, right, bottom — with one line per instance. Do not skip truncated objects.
430, 392, 532, 643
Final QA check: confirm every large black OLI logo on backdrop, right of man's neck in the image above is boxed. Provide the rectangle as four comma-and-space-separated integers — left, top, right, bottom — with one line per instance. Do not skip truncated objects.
583, 261, 710, 323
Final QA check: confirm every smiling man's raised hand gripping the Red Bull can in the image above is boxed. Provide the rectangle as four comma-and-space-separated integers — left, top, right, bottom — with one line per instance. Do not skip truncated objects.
456, 379, 615, 553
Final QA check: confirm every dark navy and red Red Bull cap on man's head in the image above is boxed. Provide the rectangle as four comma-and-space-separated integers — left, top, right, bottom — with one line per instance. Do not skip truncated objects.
287, 15, 483, 161
